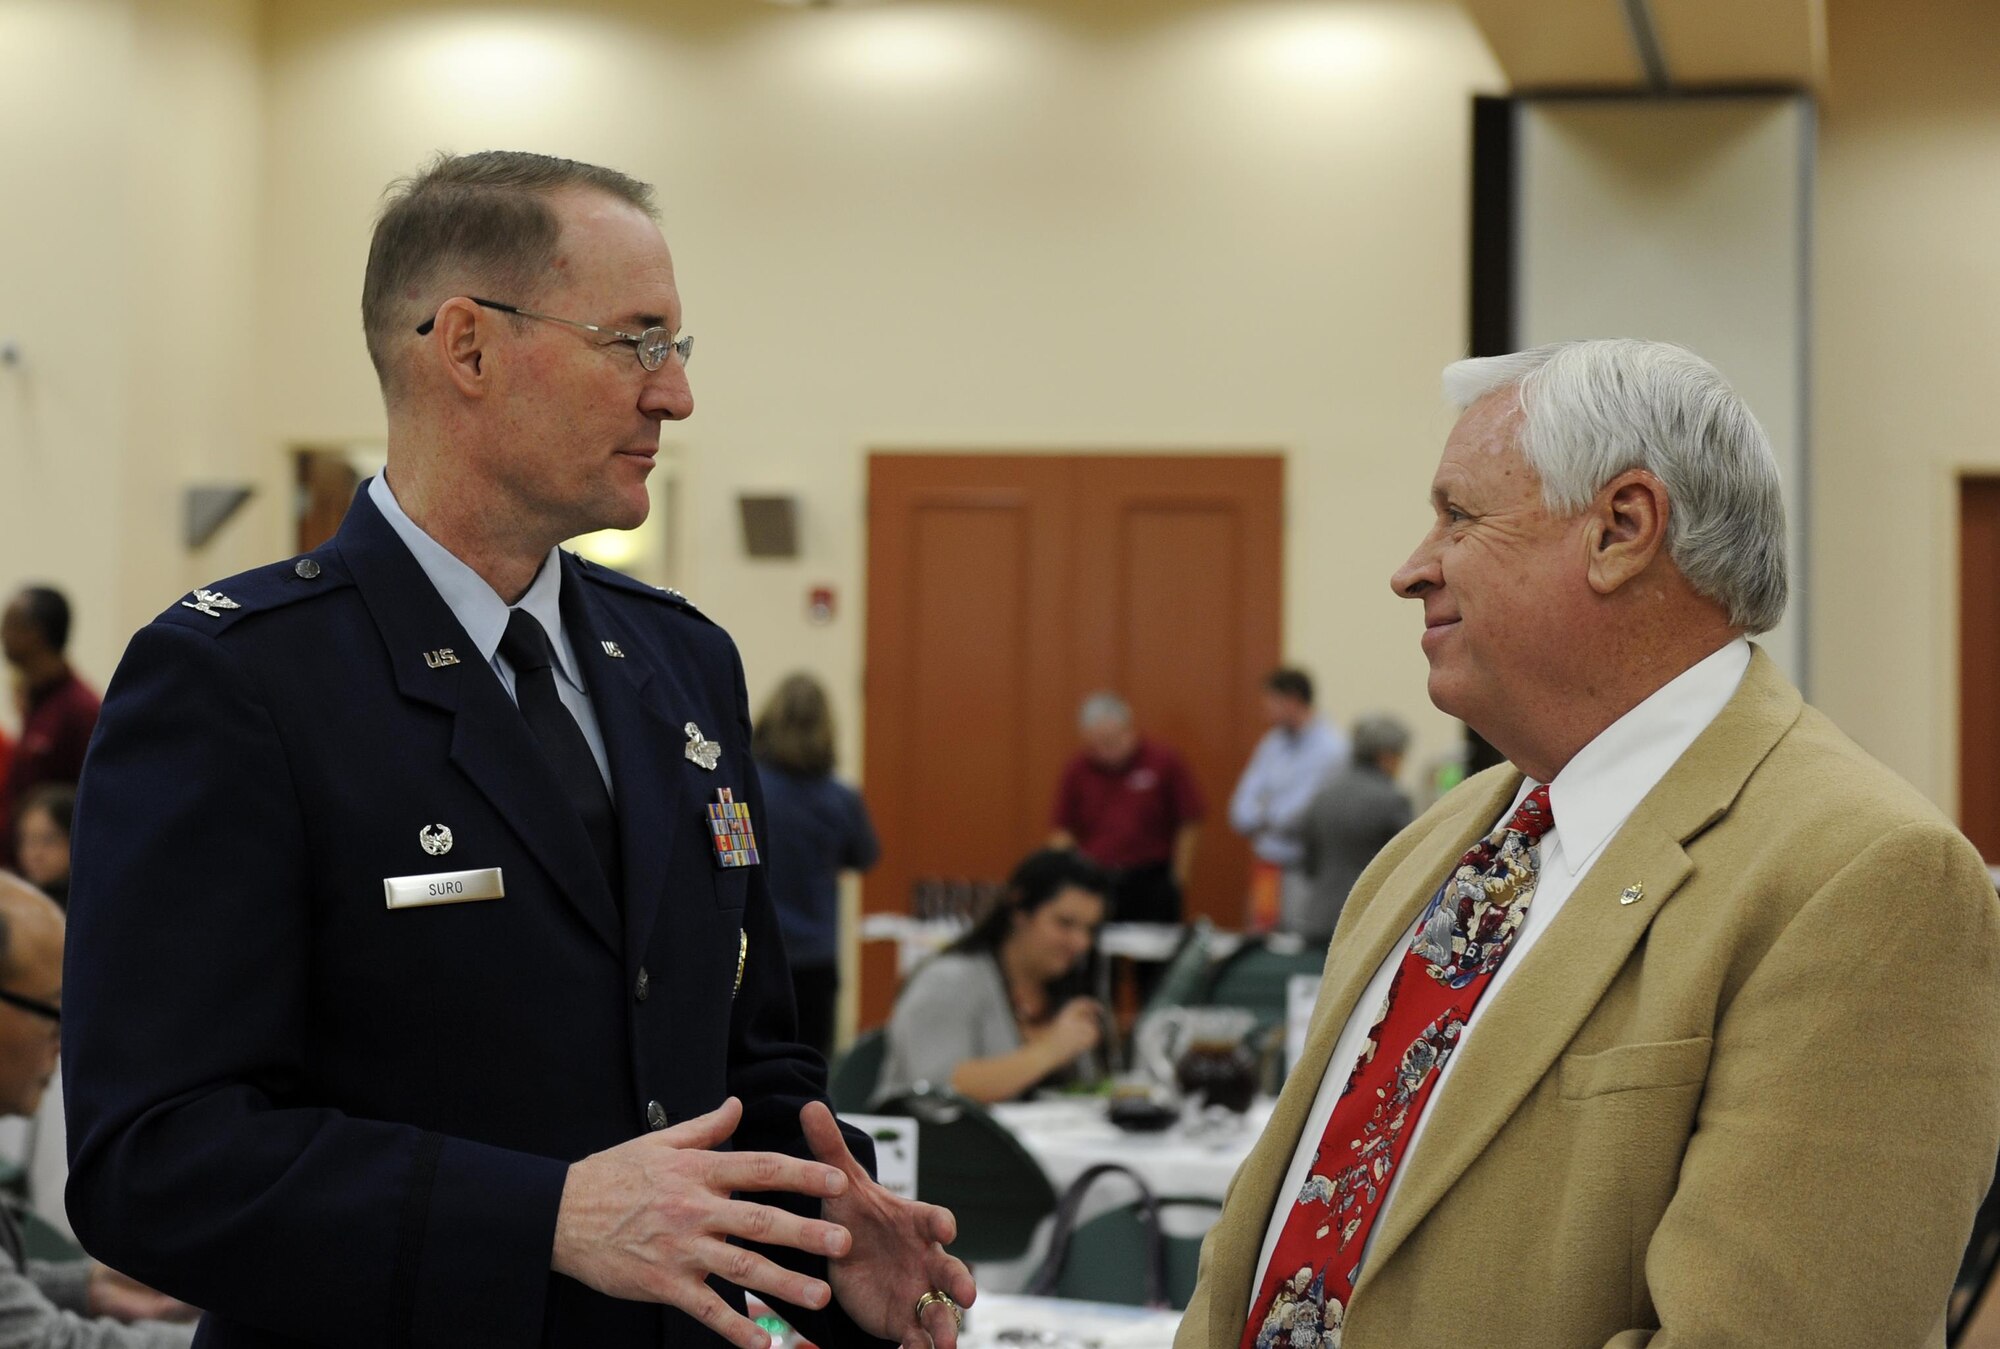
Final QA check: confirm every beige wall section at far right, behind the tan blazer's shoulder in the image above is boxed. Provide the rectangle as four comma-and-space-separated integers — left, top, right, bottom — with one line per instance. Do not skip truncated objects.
1812, 0, 2000, 809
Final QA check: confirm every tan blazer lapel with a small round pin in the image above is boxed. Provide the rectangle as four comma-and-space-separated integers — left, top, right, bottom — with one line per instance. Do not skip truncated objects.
1354, 650, 1802, 1297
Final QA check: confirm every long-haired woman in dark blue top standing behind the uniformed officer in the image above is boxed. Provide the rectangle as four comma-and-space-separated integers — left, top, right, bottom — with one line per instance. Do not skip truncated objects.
750, 675, 882, 1057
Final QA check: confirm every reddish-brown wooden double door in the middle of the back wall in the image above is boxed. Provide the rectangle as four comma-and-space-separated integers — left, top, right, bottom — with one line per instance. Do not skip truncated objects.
860, 454, 1284, 1027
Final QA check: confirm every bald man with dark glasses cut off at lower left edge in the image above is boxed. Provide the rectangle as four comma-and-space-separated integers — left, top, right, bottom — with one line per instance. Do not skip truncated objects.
0, 875, 196, 1349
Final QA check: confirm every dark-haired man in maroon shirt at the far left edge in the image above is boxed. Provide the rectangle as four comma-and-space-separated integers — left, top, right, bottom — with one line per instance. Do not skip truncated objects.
0, 586, 98, 869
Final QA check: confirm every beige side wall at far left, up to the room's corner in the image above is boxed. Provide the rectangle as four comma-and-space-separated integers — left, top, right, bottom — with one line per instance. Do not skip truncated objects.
0, 0, 260, 708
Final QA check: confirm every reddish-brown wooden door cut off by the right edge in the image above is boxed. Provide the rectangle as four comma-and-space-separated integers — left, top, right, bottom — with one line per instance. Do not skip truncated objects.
1958, 478, 2000, 863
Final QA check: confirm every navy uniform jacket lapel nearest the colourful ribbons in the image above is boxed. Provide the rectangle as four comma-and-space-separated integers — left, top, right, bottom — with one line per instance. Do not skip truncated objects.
562, 568, 702, 961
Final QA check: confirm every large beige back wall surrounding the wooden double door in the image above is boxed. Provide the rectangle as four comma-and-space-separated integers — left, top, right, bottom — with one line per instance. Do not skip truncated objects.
246, 0, 1498, 767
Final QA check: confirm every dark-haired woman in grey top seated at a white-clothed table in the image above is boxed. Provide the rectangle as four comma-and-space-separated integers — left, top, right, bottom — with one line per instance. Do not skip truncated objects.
876, 849, 1110, 1105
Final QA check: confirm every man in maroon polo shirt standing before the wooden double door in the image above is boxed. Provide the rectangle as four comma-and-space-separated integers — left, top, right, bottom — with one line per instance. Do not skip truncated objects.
1052, 693, 1202, 923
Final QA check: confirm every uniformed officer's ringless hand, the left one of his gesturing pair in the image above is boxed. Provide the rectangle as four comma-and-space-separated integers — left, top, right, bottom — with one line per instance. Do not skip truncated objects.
552, 1097, 856, 1349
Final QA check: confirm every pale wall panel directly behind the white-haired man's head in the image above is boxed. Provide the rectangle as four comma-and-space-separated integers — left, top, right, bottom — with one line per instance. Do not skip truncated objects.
1520, 98, 1810, 679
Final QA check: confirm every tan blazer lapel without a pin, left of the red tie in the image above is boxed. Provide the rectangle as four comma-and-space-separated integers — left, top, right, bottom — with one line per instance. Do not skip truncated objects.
1206, 773, 1520, 1345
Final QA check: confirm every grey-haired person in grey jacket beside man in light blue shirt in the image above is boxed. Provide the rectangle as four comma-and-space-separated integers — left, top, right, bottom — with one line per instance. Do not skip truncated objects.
1278, 717, 1414, 945
